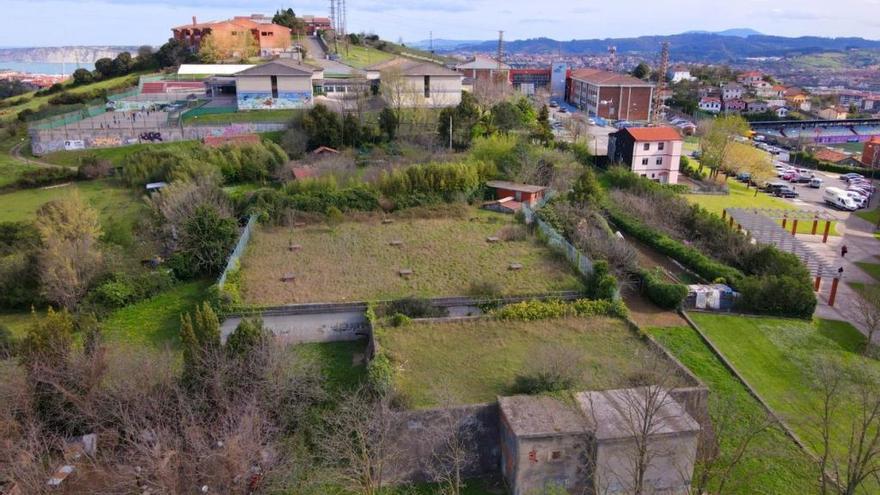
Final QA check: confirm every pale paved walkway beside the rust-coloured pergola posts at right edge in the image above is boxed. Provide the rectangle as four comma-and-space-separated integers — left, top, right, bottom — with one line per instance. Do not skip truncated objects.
812, 198, 880, 345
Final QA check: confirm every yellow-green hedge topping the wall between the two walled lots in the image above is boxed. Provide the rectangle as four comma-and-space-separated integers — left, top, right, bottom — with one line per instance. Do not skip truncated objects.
491, 299, 629, 321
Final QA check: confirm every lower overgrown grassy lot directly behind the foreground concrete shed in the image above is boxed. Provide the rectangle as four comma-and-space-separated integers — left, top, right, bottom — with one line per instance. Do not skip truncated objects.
377, 318, 688, 408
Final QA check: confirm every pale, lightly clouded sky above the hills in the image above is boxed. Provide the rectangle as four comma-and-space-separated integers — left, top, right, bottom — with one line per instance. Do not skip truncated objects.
0, 0, 880, 46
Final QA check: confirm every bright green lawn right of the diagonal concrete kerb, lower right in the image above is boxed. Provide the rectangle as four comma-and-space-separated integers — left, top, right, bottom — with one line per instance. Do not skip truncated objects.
691, 313, 880, 480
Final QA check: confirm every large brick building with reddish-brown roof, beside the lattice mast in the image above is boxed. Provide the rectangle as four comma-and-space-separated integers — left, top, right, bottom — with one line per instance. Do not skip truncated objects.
566, 69, 654, 121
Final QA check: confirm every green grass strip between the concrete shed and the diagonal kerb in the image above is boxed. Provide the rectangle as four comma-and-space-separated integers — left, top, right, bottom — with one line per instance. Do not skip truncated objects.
649, 327, 815, 495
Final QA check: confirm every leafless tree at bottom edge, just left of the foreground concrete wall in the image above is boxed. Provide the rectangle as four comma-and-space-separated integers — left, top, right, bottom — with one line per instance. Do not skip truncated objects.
319, 388, 398, 495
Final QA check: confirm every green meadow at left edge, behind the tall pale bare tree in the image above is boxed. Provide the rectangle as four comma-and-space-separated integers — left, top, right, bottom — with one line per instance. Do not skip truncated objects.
0, 180, 146, 225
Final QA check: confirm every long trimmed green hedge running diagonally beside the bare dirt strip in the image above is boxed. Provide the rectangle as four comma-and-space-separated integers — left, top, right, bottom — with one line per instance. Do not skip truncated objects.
605, 204, 743, 286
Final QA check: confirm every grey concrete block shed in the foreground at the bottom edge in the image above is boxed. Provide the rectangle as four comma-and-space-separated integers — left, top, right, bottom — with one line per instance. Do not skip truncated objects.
498, 387, 701, 495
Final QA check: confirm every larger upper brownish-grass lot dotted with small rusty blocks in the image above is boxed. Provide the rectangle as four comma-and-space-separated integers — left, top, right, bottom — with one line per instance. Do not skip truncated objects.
242, 210, 582, 305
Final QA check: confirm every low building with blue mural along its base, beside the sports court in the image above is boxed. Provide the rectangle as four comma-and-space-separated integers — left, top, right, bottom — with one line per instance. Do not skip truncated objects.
235, 59, 324, 111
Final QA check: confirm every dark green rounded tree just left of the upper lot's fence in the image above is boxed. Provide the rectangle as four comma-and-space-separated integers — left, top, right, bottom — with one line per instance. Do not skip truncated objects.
181, 204, 237, 276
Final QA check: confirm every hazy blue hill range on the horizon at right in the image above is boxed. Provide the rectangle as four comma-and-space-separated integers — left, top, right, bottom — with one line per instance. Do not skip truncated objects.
449, 30, 880, 63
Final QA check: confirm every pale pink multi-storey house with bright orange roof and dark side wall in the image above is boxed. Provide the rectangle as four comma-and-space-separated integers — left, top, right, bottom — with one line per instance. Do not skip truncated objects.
608, 127, 683, 184
